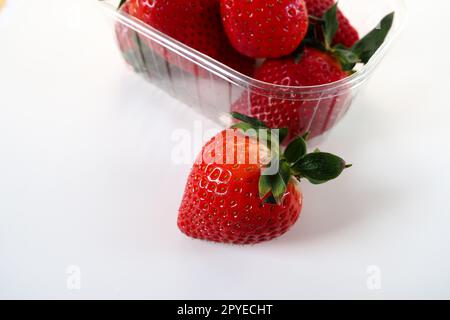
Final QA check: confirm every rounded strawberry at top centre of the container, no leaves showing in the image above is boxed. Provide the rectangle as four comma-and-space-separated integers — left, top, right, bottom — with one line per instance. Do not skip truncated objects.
220, 0, 308, 58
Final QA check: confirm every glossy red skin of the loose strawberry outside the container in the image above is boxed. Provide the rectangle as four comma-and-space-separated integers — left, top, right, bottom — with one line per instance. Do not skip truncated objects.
178, 131, 302, 244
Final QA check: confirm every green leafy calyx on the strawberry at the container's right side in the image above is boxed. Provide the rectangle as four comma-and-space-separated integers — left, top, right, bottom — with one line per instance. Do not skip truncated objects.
304, 3, 395, 71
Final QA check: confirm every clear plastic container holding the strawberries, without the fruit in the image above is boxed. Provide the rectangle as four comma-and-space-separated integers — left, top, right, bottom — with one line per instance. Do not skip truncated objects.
101, 0, 406, 143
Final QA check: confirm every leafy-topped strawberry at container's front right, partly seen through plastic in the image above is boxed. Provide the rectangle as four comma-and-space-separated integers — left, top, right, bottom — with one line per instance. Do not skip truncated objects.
232, 5, 394, 141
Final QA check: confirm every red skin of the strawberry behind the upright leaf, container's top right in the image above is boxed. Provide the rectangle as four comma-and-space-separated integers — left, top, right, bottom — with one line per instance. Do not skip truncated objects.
305, 0, 359, 48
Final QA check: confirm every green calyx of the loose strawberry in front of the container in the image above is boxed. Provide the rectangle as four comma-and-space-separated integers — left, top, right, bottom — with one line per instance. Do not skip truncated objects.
231, 112, 350, 205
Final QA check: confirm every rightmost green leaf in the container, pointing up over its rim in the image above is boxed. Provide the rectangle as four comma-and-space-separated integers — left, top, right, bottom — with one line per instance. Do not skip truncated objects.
351, 12, 395, 63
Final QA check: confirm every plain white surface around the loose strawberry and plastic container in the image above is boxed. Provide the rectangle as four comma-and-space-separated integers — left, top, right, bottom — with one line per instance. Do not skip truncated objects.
0, 0, 450, 299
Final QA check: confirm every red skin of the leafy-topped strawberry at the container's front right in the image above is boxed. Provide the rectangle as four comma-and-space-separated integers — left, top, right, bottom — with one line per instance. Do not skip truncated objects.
232, 47, 350, 141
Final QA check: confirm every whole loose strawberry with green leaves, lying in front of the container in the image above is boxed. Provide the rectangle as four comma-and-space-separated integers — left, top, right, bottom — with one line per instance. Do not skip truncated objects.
178, 113, 349, 244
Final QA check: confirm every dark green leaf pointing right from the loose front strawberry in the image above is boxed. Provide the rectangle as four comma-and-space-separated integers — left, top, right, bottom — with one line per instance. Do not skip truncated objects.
293, 152, 347, 184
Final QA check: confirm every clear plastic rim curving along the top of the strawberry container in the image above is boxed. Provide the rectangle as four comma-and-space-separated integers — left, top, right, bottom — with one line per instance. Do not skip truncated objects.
98, 0, 406, 96
